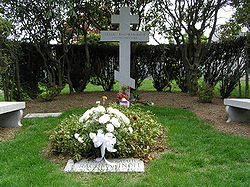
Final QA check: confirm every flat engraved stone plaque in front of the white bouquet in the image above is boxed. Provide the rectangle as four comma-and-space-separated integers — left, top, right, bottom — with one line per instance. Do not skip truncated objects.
64, 158, 144, 172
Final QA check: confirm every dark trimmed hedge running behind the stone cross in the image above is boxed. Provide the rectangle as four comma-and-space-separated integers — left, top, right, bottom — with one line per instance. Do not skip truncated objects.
3, 37, 247, 101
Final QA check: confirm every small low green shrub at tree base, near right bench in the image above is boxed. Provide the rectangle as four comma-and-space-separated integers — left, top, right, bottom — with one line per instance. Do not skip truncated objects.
198, 82, 214, 103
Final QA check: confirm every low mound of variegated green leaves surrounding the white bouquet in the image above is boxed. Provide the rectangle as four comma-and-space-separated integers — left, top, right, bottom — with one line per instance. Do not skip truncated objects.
50, 104, 164, 160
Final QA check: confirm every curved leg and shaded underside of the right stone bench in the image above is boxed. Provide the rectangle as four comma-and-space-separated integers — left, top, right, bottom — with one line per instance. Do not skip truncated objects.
226, 106, 250, 123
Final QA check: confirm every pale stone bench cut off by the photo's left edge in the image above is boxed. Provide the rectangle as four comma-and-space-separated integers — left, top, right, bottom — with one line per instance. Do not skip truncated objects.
0, 102, 25, 128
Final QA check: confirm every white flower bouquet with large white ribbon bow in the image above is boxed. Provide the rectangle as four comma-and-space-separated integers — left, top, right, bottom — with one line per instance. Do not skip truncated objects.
74, 106, 133, 161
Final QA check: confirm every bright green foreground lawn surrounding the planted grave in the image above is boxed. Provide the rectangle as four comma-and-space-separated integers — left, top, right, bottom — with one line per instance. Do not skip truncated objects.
0, 107, 250, 187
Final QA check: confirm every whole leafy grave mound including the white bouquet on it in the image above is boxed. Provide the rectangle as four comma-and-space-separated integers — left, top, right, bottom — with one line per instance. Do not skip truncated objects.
50, 104, 166, 161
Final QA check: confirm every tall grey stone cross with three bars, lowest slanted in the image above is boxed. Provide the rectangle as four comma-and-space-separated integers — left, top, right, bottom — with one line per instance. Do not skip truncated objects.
101, 7, 149, 88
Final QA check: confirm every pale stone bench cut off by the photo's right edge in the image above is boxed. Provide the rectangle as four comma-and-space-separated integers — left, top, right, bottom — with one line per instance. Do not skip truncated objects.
224, 99, 250, 123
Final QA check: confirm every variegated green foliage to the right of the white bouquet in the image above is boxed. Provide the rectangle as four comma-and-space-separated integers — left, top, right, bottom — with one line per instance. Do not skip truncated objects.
115, 105, 165, 157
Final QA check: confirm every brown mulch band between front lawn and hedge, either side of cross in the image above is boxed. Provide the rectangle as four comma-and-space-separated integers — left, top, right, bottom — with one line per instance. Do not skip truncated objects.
0, 91, 250, 142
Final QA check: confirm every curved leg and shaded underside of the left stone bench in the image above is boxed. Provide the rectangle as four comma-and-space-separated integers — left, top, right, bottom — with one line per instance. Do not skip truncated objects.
0, 110, 23, 128
